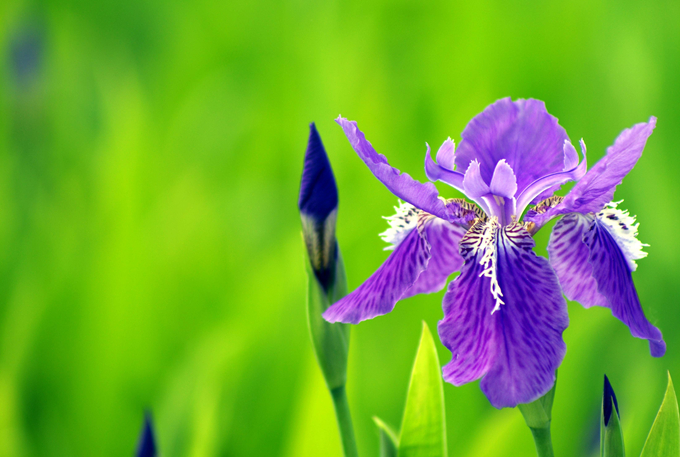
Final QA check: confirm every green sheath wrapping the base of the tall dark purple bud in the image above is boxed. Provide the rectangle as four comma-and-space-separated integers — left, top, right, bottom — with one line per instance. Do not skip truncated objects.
307, 249, 349, 390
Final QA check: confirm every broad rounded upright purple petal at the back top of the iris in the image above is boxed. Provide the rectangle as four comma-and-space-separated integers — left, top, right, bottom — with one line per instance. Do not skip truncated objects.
456, 98, 569, 192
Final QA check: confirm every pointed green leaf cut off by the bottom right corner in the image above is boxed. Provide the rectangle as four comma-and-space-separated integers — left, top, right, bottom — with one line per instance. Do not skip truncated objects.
640, 373, 680, 457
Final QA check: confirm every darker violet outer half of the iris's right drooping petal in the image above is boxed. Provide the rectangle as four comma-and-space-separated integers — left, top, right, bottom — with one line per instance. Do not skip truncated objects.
583, 214, 666, 357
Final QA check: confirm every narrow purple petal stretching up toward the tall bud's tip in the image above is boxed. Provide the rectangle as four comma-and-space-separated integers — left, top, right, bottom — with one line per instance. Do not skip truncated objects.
336, 117, 447, 219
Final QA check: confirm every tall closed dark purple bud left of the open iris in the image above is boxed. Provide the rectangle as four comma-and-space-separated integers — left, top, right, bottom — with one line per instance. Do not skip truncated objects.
298, 123, 338, 291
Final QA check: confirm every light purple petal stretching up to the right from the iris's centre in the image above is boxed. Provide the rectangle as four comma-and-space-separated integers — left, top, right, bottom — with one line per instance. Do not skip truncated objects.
528, 116, 656, 227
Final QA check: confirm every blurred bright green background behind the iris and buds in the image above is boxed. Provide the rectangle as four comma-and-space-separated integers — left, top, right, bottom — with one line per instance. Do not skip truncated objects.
0, 0, 680, 457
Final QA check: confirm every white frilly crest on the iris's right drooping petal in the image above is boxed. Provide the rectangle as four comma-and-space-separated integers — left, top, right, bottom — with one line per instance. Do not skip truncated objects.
597, 200, 649, 271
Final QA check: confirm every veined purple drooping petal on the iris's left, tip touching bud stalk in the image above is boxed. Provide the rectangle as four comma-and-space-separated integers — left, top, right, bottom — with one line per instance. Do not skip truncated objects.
323, 213, 464, 324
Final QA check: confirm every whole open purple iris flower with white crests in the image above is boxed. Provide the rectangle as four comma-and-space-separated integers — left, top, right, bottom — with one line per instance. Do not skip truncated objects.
323, 98, 666, 408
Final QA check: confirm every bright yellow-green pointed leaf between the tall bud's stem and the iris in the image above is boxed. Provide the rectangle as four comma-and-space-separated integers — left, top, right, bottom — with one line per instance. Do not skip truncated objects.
399, 322, 447, 457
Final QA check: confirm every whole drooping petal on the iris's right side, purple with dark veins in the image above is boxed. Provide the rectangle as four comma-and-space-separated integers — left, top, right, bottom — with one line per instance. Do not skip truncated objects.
548, 212, 666, 357
